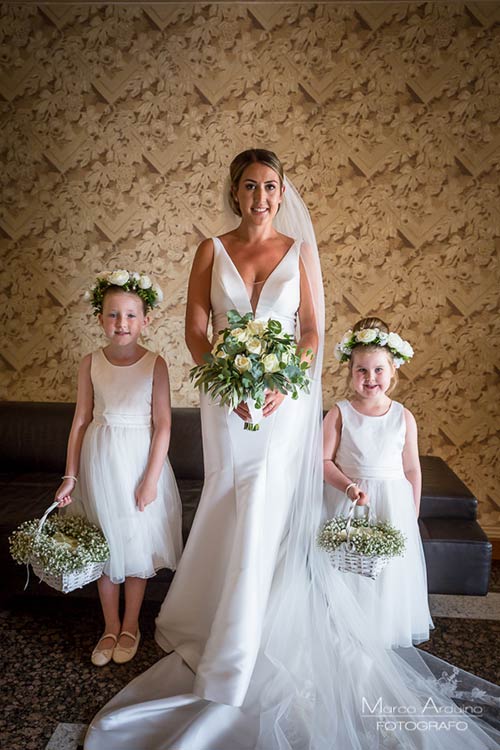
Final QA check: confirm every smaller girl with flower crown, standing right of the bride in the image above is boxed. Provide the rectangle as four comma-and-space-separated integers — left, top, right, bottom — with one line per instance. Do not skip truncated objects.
323, 318, 433, 647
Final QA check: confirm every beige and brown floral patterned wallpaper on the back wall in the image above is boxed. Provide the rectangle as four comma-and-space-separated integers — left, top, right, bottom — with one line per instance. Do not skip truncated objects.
0, 2, 500, 538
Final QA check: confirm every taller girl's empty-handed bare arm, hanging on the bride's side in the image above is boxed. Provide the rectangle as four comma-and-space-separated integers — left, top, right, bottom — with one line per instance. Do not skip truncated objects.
135, 357, 172, 511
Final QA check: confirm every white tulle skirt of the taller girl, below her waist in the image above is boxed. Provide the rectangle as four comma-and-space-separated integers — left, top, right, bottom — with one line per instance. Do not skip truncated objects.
68, 422, 182, 583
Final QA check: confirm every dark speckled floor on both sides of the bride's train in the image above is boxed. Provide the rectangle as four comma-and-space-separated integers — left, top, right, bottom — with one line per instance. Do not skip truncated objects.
0, 563, 500, 750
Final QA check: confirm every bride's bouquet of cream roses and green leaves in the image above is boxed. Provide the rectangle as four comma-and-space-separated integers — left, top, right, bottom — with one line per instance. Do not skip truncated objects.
190, 310, 312, 430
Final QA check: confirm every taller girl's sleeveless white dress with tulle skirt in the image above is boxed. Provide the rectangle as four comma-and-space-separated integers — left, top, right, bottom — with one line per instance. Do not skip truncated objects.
67, 349, 182, 583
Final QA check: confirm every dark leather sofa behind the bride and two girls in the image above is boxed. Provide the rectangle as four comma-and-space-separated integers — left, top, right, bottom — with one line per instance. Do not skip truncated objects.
0, 401, 491, 601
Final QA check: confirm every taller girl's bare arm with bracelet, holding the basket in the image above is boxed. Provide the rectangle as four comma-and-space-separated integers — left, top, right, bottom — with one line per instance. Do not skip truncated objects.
55, 354, 94, 507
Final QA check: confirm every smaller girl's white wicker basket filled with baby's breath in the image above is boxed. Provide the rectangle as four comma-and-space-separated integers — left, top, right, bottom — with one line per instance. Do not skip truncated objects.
318, 516, 405, 578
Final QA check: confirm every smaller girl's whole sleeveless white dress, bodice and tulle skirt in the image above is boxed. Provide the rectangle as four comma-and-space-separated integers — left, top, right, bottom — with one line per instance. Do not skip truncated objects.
325, 400, 432, 647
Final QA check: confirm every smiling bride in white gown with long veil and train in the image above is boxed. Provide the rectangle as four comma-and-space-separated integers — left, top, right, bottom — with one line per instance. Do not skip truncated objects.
85, 149, 500, 750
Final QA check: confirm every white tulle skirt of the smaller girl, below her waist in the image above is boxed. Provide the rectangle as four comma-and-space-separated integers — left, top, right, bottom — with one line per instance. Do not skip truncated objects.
325, 477, 434, 648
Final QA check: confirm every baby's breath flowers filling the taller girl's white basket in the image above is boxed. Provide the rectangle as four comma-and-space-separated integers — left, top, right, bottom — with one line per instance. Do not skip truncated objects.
9, 515, 109, 575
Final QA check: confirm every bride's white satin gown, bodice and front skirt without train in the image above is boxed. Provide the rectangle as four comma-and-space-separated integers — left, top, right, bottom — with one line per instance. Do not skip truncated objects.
156, 238, 309, 706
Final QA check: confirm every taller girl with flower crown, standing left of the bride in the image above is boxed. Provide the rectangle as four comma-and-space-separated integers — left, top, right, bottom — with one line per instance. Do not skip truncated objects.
55, 270, 182, 666
